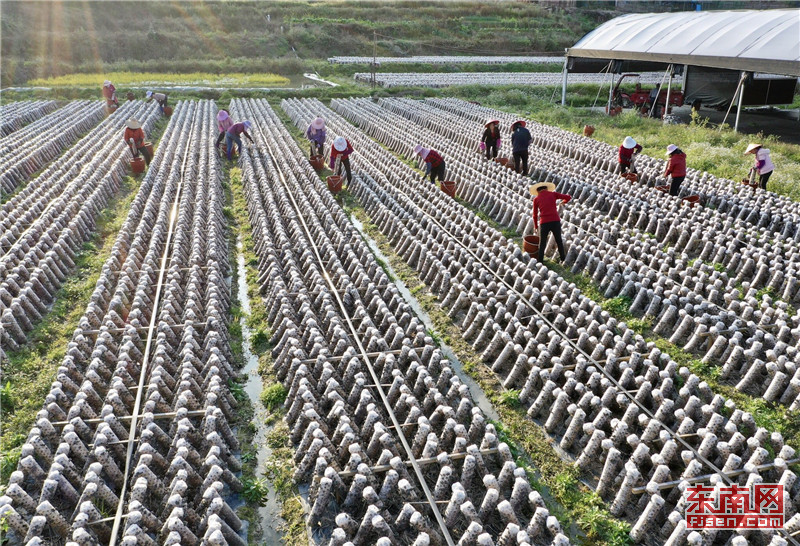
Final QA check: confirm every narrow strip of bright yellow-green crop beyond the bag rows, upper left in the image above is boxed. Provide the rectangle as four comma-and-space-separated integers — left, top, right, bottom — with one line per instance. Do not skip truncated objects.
28, 72, 289, 88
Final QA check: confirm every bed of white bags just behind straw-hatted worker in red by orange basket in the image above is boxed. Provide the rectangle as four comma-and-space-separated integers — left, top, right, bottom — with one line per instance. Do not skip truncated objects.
365, 95, 800, 409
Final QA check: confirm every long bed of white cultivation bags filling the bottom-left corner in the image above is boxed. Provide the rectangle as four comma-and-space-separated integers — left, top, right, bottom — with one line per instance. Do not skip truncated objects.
0, 101, 246, 546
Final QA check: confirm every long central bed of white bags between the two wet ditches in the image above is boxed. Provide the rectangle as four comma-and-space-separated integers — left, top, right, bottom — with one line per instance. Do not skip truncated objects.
241, 95, 569, 546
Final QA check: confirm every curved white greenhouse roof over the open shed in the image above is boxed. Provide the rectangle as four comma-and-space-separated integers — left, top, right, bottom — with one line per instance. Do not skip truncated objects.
567, 9, 800, 77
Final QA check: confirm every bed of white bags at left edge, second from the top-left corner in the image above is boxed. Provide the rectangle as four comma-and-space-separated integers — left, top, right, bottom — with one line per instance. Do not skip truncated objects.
0, 100, 105, 194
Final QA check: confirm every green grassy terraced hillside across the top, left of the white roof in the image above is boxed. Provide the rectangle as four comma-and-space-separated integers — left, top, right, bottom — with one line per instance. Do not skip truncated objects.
0, 0, 616, 85
